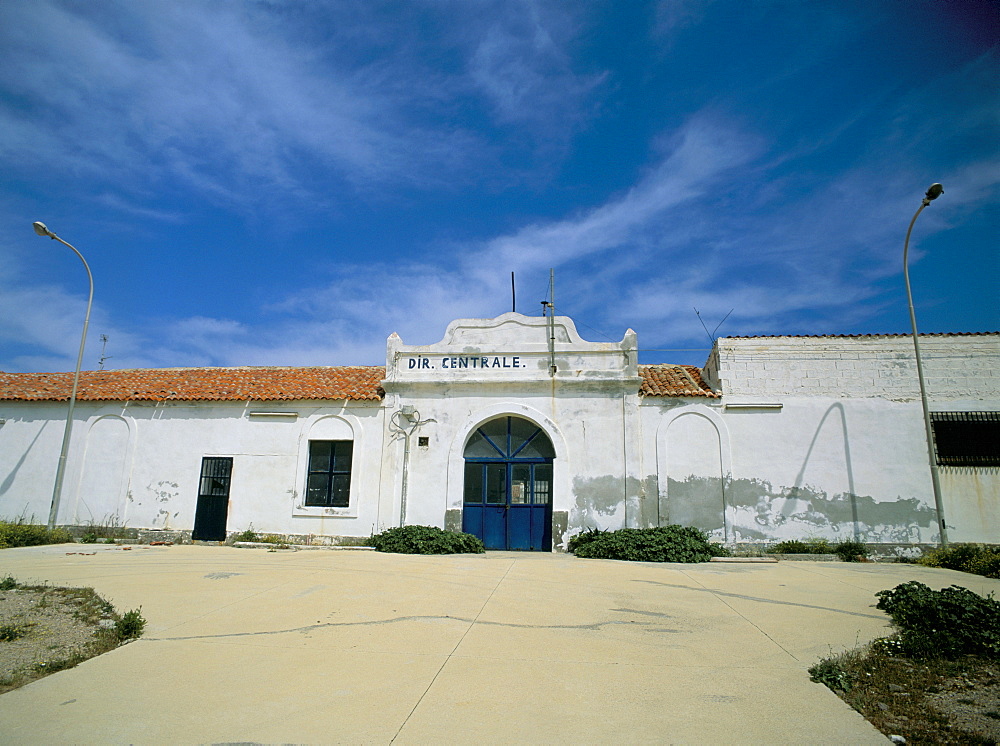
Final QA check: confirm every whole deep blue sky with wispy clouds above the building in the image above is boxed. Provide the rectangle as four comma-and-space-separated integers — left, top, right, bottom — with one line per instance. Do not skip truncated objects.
0, 0, 1000, 371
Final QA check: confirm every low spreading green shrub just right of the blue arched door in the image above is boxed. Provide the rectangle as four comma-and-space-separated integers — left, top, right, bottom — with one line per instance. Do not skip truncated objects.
576, 525, 729, 562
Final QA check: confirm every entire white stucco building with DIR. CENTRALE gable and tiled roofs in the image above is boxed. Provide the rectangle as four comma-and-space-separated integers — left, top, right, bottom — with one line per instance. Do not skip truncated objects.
0, 313, 1000, 551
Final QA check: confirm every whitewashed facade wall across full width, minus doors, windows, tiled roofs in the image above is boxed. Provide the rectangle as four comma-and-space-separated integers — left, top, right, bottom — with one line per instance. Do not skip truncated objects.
0, 328, 1000, 547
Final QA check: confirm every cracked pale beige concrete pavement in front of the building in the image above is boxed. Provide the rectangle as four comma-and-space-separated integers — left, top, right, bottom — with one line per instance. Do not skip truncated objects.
0, 545, 1000, 744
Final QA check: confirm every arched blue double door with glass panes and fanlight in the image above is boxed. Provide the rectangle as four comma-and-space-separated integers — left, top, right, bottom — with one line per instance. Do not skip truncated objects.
462, 416, 555, 552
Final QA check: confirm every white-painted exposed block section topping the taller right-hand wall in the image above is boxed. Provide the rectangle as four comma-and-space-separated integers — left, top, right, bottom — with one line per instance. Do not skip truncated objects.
705, 333, 1000, 402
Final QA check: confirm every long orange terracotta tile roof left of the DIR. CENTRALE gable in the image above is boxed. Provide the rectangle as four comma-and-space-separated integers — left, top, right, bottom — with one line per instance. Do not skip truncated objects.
0, 366, 385, 401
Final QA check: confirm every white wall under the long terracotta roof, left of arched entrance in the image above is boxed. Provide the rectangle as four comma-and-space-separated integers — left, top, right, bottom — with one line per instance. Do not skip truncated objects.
0, 402, 383, 536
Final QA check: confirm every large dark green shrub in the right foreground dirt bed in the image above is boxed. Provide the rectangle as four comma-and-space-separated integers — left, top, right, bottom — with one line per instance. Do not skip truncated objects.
875, 580, 1000, 660
